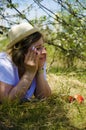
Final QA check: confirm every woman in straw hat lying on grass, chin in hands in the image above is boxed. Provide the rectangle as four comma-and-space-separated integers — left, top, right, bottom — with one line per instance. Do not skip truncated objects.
0, 23, 51, 102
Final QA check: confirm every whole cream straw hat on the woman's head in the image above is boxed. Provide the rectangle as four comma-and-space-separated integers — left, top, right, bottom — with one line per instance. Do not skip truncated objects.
7, 23, 39, 48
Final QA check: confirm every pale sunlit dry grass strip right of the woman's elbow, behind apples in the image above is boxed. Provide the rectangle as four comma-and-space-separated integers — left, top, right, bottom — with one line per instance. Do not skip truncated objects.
47, 74, 86, 98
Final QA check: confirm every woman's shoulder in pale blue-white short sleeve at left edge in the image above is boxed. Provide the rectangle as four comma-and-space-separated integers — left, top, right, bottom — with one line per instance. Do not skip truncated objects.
0, 52, 19, 86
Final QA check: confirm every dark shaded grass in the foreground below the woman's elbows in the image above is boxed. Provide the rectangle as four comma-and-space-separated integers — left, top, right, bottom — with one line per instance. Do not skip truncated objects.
0, 94, 85, 130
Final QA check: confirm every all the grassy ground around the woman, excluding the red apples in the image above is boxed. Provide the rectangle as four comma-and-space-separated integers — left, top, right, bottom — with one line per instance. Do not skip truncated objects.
0, 72, 86, 130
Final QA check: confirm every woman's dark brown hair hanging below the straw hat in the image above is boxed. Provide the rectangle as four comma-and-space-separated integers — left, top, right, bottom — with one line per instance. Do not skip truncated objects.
11, 32, 43, 67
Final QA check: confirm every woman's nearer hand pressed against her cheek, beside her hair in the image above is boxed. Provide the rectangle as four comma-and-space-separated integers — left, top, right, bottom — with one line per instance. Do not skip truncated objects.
24, 46, 39, 72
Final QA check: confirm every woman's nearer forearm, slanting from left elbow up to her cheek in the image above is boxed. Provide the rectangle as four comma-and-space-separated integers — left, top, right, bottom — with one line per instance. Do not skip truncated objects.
8, 71, 35, 100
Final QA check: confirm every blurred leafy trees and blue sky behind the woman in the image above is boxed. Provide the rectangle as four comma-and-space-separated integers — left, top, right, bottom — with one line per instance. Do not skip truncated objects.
0, 0, 86, 70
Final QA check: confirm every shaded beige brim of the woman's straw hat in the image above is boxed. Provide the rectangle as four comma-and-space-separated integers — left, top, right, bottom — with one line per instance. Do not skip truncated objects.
7, 28, 39, 49
